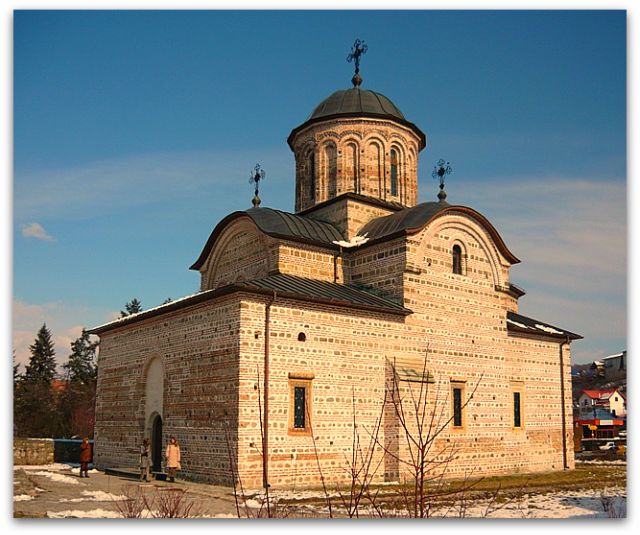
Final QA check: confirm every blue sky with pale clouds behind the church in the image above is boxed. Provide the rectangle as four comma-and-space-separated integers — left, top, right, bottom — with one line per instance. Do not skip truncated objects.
13, 11, 627, 368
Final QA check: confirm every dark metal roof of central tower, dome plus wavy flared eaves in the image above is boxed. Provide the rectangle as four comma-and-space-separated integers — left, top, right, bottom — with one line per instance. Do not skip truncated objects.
287, 87, 427, 150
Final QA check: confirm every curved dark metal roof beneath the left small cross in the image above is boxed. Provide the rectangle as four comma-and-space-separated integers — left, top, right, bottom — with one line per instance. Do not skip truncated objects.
189, 208, 344, 270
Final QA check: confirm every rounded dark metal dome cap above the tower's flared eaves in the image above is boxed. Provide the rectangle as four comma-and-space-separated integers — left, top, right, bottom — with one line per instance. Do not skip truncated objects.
307, 87, 405, 121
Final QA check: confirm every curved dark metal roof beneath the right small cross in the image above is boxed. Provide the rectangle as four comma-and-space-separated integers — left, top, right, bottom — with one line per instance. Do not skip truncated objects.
358, 201, 520, 264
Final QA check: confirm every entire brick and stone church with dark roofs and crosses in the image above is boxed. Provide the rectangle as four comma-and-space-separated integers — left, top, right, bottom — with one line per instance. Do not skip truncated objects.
90, 47, 581, 488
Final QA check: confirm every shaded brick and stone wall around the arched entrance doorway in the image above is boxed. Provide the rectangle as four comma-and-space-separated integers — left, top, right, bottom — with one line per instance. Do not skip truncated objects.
95, 296, 240, 484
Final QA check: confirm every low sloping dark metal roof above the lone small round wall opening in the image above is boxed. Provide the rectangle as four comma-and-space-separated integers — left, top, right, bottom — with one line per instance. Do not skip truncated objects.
236, 274, 411, 315
